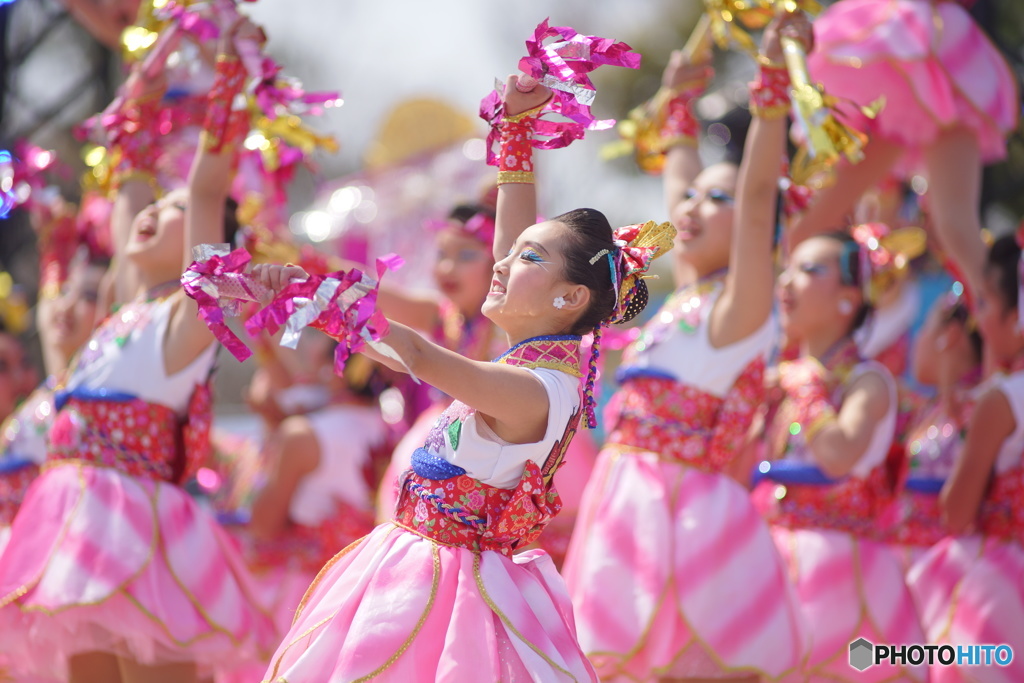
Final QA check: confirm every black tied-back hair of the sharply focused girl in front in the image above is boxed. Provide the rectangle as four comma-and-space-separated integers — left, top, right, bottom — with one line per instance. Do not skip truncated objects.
552, 209, 647, 335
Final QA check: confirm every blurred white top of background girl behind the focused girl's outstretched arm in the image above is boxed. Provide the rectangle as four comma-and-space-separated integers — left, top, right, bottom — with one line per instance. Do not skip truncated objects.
288, 405, 387, 526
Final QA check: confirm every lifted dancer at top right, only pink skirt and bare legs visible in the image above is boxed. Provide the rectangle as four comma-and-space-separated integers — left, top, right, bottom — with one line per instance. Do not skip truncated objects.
793, 0, 1020, 301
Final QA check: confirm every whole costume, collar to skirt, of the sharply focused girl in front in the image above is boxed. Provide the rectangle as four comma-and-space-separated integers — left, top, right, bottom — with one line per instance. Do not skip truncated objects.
265, 337, 597, 683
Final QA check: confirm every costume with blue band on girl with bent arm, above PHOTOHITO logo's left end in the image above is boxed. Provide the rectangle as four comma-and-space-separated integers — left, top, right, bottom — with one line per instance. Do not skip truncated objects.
753, 341, 927, 683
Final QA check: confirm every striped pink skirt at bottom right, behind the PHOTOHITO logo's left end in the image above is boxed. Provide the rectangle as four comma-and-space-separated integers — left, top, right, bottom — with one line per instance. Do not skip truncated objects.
772, 526, 929, 683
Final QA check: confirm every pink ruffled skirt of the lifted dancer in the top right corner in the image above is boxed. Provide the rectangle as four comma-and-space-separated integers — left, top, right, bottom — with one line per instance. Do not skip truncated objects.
808, 0, 1020, 161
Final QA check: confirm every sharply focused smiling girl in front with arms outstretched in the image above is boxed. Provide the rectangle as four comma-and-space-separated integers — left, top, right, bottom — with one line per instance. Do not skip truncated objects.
249, 80, 671, 683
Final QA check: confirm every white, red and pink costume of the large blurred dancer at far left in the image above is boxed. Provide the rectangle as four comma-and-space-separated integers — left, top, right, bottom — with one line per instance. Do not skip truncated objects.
0, 299, 273, 678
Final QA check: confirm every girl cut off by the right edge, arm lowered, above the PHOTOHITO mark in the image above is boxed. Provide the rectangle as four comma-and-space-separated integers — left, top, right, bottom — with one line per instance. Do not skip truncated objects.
908, 237, 1024, 683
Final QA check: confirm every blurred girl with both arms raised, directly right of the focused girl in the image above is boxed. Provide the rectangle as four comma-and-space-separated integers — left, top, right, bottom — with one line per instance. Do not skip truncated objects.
565, 14, 810, 681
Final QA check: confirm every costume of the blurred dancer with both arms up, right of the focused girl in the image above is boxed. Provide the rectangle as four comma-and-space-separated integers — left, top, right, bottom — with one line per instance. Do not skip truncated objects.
564, 276, 806, 681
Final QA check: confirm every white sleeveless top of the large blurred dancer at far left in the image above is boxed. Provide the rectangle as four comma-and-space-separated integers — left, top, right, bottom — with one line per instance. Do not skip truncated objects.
65, 297, 217, 416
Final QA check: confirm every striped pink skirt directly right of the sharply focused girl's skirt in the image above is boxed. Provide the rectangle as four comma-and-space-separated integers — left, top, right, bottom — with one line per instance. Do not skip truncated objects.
564, 445, 807, 681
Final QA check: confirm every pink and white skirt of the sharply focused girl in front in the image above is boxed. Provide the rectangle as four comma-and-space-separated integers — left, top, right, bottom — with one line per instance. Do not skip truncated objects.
264, 523, 597, 683
